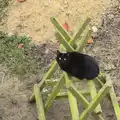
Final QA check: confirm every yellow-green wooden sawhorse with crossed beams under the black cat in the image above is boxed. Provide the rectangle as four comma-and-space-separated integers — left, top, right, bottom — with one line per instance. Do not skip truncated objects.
30, 17, 120, 120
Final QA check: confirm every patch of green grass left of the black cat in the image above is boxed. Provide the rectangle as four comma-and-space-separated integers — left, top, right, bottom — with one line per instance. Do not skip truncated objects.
0, 32, 41, 75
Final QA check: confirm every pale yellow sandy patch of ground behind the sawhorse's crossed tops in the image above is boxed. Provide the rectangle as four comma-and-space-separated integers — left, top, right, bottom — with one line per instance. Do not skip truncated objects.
5, 0, 111, 42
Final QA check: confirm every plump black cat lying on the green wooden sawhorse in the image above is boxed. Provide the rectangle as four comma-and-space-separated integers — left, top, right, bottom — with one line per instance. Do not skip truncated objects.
56, 50, 99, 80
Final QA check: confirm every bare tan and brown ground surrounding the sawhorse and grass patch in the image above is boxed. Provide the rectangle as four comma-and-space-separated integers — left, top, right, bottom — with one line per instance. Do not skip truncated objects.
0, 0, 120, 120
